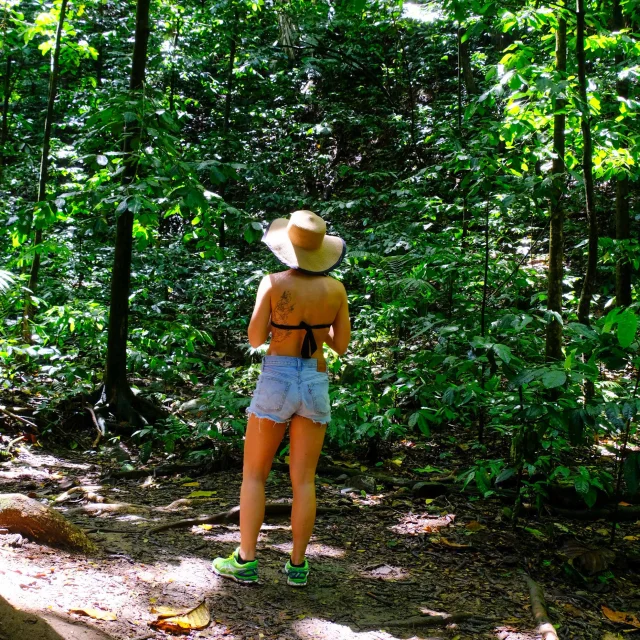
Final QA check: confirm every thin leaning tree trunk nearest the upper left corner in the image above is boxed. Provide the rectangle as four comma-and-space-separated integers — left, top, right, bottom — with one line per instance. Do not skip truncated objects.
22, 0, 68, 342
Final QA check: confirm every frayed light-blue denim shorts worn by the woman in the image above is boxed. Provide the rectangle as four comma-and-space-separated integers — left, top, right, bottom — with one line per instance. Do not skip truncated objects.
247, 356, 331, 424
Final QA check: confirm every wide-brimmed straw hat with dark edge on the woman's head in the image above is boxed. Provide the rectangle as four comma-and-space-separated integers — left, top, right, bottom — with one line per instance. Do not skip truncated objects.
262, 211, 347, 275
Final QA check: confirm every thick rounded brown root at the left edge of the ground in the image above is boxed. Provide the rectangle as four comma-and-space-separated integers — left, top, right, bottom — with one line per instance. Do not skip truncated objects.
0, 493, 98, 553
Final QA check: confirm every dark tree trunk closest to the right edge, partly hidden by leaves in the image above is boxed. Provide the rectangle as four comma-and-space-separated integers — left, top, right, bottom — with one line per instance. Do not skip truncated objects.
613, 0, 631, 307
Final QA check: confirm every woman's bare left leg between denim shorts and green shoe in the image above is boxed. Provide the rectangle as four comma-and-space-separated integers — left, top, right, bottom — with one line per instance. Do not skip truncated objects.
240, 414, 286, 560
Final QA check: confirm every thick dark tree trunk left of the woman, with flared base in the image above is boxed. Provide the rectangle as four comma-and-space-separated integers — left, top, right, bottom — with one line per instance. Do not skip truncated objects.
104, 0, 151, 420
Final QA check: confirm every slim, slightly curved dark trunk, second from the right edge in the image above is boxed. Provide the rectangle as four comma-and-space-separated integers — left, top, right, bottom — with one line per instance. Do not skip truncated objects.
576, 0, 598, 325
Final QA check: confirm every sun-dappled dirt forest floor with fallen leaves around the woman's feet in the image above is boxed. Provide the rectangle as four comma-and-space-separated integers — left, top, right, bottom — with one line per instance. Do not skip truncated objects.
0, 438, 640, 640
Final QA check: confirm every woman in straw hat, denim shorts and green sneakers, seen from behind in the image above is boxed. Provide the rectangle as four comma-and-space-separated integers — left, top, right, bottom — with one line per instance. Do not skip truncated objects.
213, 211, 351, 587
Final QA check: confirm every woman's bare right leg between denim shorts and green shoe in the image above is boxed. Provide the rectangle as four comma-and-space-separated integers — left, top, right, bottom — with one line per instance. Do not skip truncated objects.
289, 415, 327, 564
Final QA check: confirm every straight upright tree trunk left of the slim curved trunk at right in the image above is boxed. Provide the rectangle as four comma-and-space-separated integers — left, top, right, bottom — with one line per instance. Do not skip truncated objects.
545, 14, 567, 361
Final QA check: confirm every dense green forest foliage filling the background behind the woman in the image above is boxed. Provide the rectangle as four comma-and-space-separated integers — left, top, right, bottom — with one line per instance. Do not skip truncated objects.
0, 0, 640, 505
